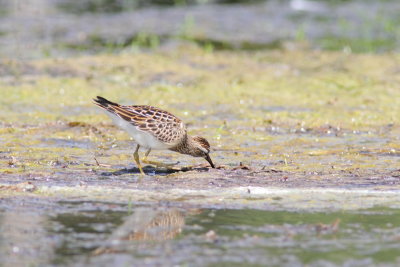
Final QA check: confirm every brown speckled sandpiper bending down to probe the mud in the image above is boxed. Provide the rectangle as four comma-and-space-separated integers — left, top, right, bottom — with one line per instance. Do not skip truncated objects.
93, 96, 215, 174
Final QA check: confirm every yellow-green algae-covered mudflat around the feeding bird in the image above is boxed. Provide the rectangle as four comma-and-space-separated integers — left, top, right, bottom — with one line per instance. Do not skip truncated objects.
0, 46, 400, 193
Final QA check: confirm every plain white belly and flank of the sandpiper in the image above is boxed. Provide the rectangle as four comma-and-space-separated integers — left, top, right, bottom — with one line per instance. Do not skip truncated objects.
107, 112, 170, 149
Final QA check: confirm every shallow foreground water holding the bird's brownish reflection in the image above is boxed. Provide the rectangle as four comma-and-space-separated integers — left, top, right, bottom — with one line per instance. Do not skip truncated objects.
0, 201, 400, 266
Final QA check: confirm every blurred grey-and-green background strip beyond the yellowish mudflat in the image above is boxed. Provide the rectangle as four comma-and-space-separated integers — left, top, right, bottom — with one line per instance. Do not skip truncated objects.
0, 0, 400, 58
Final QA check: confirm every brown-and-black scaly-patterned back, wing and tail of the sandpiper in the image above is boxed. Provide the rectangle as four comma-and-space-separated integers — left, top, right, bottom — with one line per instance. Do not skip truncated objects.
95, 97, 186, 145
